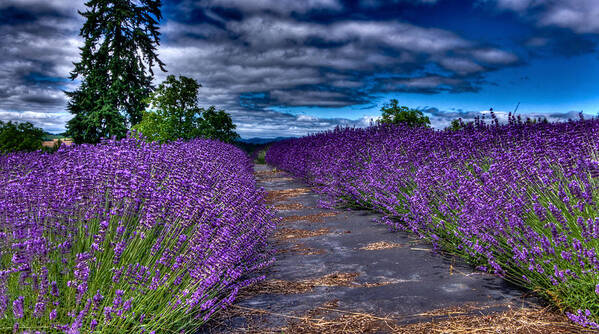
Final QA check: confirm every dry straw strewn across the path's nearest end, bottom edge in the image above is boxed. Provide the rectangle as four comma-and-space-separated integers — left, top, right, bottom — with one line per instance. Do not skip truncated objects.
227, 301, 595, 334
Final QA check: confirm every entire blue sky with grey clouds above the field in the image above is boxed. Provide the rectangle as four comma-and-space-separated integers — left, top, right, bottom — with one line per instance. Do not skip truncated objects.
0, 0, 599, 138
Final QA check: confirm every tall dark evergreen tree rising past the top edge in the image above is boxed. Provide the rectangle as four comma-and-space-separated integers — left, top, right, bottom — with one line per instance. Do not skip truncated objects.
66, 0, 166, 143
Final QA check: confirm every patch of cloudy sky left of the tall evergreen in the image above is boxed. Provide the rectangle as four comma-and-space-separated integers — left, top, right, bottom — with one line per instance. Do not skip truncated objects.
0, 0, 81, 131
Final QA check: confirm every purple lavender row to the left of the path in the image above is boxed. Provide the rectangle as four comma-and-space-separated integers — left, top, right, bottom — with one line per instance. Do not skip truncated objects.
0, 138, 274, 333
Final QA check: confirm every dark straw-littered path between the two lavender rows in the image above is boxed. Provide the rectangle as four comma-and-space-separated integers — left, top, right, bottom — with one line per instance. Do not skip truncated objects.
207, 165, 579, 334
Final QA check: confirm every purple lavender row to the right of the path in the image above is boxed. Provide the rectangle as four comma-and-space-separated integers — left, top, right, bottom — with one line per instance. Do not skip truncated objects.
266, 117, 599, 328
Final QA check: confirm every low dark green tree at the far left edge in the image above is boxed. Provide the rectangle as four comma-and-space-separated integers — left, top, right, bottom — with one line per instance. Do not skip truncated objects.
0, 121, 44, 153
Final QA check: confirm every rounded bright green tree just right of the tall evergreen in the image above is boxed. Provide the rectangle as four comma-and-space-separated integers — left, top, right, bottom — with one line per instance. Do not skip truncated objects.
133, 75, 239, 143
